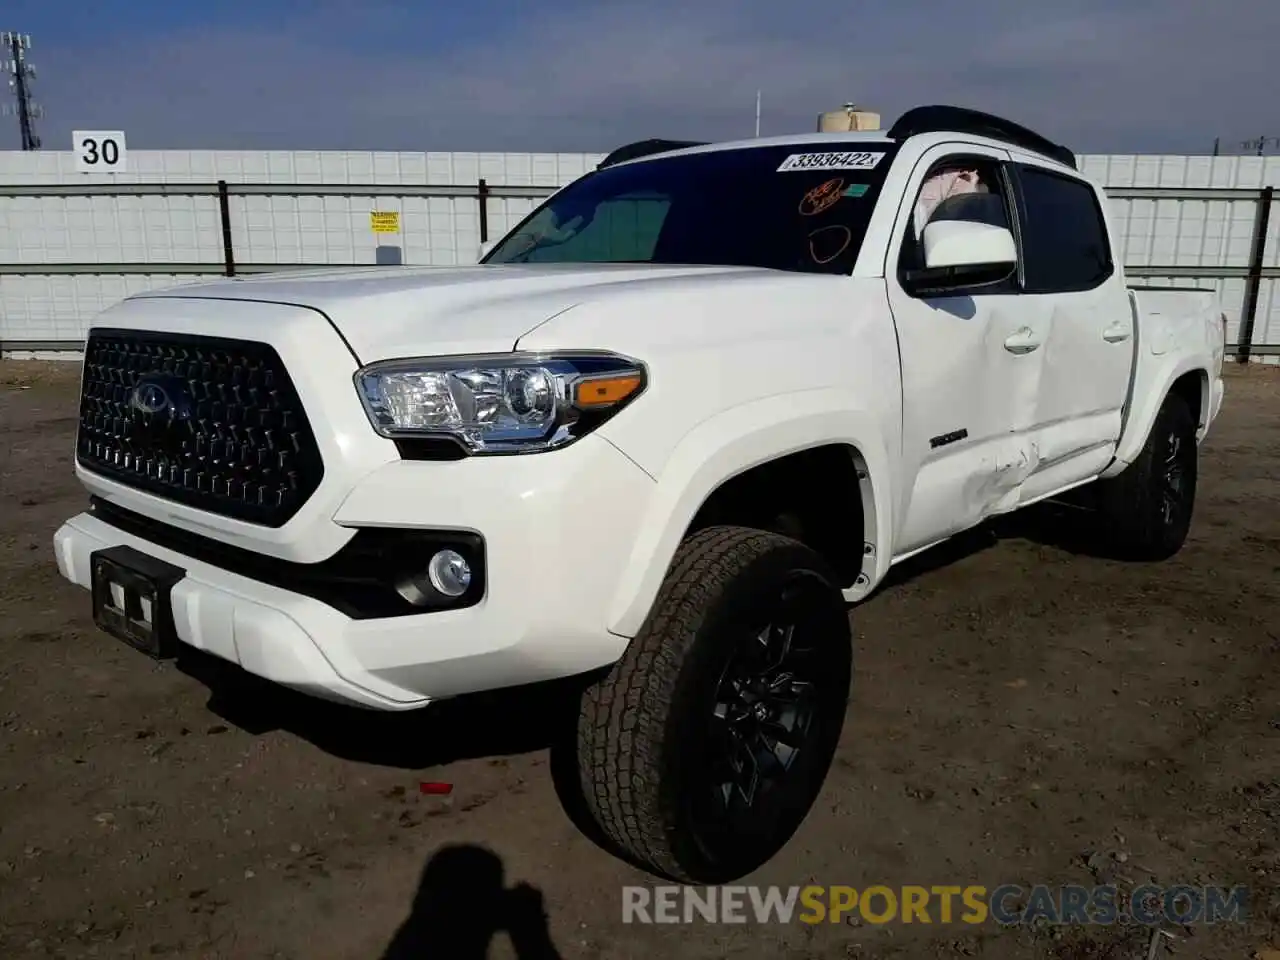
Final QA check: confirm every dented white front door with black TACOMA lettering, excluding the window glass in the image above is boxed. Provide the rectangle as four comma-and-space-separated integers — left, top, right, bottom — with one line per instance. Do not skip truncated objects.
884, 146, 1046, 557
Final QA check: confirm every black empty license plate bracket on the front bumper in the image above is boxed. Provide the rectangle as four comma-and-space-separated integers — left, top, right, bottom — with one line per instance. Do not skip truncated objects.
90, 547, 187, 660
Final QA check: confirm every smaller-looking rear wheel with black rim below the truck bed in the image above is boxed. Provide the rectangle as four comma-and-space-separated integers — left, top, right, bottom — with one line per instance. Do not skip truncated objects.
1096, 394, 1198, 561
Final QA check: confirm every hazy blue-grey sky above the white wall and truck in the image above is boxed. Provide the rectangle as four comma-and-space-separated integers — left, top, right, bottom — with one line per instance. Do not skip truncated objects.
0, 0, 1280, 152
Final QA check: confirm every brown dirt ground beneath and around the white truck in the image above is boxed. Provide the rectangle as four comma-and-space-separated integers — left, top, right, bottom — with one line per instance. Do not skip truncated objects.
0, 361, 1280, 960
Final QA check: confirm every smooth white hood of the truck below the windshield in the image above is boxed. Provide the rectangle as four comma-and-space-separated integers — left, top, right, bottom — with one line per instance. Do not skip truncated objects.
133, 264, 776, 364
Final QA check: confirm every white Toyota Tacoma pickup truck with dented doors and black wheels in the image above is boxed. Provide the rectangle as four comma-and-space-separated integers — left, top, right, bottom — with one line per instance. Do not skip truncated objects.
54, 108, 1225, 882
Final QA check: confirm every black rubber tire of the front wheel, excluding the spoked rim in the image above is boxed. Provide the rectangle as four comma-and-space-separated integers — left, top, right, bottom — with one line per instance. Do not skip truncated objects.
577, 526, 852, 883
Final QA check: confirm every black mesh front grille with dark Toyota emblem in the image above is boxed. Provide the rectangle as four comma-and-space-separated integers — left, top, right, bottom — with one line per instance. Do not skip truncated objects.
76, 330, 324, 527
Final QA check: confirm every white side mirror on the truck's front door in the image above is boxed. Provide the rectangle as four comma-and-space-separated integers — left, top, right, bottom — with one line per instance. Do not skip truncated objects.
904, 220, 1018, 293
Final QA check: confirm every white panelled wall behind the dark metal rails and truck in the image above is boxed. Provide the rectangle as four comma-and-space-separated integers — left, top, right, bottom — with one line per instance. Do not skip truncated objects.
0, 150, 1280, 361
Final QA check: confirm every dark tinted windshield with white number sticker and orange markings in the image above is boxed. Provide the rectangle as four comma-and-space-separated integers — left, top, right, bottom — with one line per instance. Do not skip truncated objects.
483, 142, 896, 274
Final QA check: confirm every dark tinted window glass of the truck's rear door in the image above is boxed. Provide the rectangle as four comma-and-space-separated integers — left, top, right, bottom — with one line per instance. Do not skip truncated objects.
1018, 165, 1115, 293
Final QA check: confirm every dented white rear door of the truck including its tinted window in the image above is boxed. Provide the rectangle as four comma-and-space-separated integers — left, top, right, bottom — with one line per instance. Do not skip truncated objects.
1011, 151, 1134, 503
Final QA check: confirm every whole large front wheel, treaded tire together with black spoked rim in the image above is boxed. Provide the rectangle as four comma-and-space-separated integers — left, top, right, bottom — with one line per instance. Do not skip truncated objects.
577, 526, 852, 883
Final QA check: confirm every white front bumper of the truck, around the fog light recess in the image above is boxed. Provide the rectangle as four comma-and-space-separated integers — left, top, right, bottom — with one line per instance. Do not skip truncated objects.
54, 436, 654, 710
